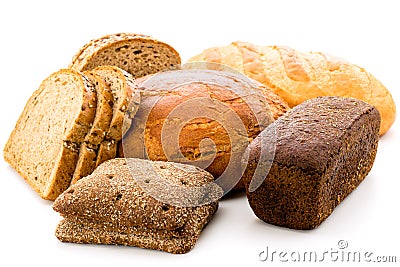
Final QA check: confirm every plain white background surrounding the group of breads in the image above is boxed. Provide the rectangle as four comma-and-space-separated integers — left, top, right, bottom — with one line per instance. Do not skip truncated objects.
0, 0, 400, 266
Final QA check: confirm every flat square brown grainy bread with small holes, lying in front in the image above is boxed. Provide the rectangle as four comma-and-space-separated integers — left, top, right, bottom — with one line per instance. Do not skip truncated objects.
53, 158, 223, 253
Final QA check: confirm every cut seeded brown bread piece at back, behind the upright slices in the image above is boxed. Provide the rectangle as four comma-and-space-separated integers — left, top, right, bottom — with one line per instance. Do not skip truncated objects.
70, 33, 181, 78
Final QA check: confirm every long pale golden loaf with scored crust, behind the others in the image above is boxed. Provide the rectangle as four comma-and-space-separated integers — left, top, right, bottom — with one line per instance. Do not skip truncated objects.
188, 42, 396, 135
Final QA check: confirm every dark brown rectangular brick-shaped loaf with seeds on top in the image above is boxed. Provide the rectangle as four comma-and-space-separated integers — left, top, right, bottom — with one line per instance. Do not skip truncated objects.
244, 97, 380, 229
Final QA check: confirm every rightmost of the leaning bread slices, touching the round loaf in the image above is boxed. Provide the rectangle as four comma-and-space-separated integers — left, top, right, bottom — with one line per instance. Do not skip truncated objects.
93, 66, 140, 166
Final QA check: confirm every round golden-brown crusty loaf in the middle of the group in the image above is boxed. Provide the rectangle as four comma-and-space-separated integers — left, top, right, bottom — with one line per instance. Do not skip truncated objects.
119, 70, 289, 190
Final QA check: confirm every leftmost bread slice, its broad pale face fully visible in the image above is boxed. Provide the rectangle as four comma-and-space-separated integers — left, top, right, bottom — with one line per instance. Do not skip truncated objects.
4, 70, 97, 200
